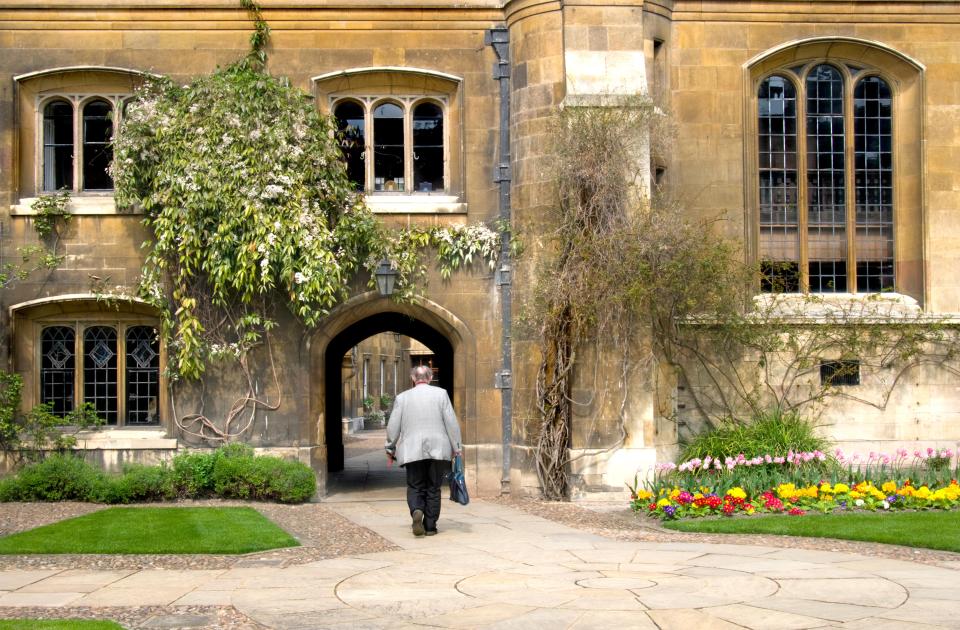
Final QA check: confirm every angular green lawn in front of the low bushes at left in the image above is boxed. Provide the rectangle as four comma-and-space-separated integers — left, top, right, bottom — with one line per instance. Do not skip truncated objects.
0, 507, 299, 556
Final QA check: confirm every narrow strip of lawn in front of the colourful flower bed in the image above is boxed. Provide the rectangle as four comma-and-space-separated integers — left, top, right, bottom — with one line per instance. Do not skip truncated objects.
663, 511, 960, 552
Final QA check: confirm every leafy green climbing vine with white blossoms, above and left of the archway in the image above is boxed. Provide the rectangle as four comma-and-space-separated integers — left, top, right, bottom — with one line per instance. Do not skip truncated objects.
111, 0, 499, 440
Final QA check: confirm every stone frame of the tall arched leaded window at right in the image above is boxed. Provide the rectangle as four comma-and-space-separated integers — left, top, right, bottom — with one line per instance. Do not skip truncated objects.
743, 37, 927, 302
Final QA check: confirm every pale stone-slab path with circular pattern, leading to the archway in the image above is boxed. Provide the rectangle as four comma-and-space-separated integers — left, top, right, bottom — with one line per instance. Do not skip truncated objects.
0, 490, 960, 630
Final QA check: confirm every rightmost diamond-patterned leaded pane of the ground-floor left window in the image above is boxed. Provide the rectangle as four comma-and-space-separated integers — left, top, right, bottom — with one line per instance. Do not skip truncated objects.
126, 326, 160, 424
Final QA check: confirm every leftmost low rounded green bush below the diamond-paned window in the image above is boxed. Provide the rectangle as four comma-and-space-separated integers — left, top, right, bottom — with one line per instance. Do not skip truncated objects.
3, 453, 107, 501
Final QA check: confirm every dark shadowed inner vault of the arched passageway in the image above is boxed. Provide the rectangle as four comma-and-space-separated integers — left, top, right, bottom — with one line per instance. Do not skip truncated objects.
323, 312, 456, 472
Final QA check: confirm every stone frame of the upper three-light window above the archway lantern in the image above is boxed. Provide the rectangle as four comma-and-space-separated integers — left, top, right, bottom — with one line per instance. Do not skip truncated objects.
312, 66, 467, 214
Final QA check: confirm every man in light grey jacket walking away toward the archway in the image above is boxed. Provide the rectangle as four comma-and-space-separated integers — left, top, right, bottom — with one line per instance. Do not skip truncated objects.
386, 365, 462, 536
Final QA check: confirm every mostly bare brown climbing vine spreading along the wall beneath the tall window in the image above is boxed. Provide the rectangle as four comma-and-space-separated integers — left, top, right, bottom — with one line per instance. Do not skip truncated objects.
528, 102, 960, 499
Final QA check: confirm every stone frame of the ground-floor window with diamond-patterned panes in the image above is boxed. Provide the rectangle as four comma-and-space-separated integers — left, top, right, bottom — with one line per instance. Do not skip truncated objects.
10, 294, 170, 430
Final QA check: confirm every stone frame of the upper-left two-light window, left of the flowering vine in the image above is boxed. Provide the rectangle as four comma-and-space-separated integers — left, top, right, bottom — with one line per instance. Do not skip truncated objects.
11, 66, 148, 216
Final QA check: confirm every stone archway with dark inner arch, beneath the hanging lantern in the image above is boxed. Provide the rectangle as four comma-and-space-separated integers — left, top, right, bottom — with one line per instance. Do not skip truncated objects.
301, 292, 476, 483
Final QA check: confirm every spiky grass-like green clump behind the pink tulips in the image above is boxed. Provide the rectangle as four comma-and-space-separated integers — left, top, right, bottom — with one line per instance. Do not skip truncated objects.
680, 410, 829, 462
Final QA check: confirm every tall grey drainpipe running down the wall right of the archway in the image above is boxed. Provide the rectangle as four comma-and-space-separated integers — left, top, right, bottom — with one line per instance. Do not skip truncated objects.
483, 27, 513, 494
